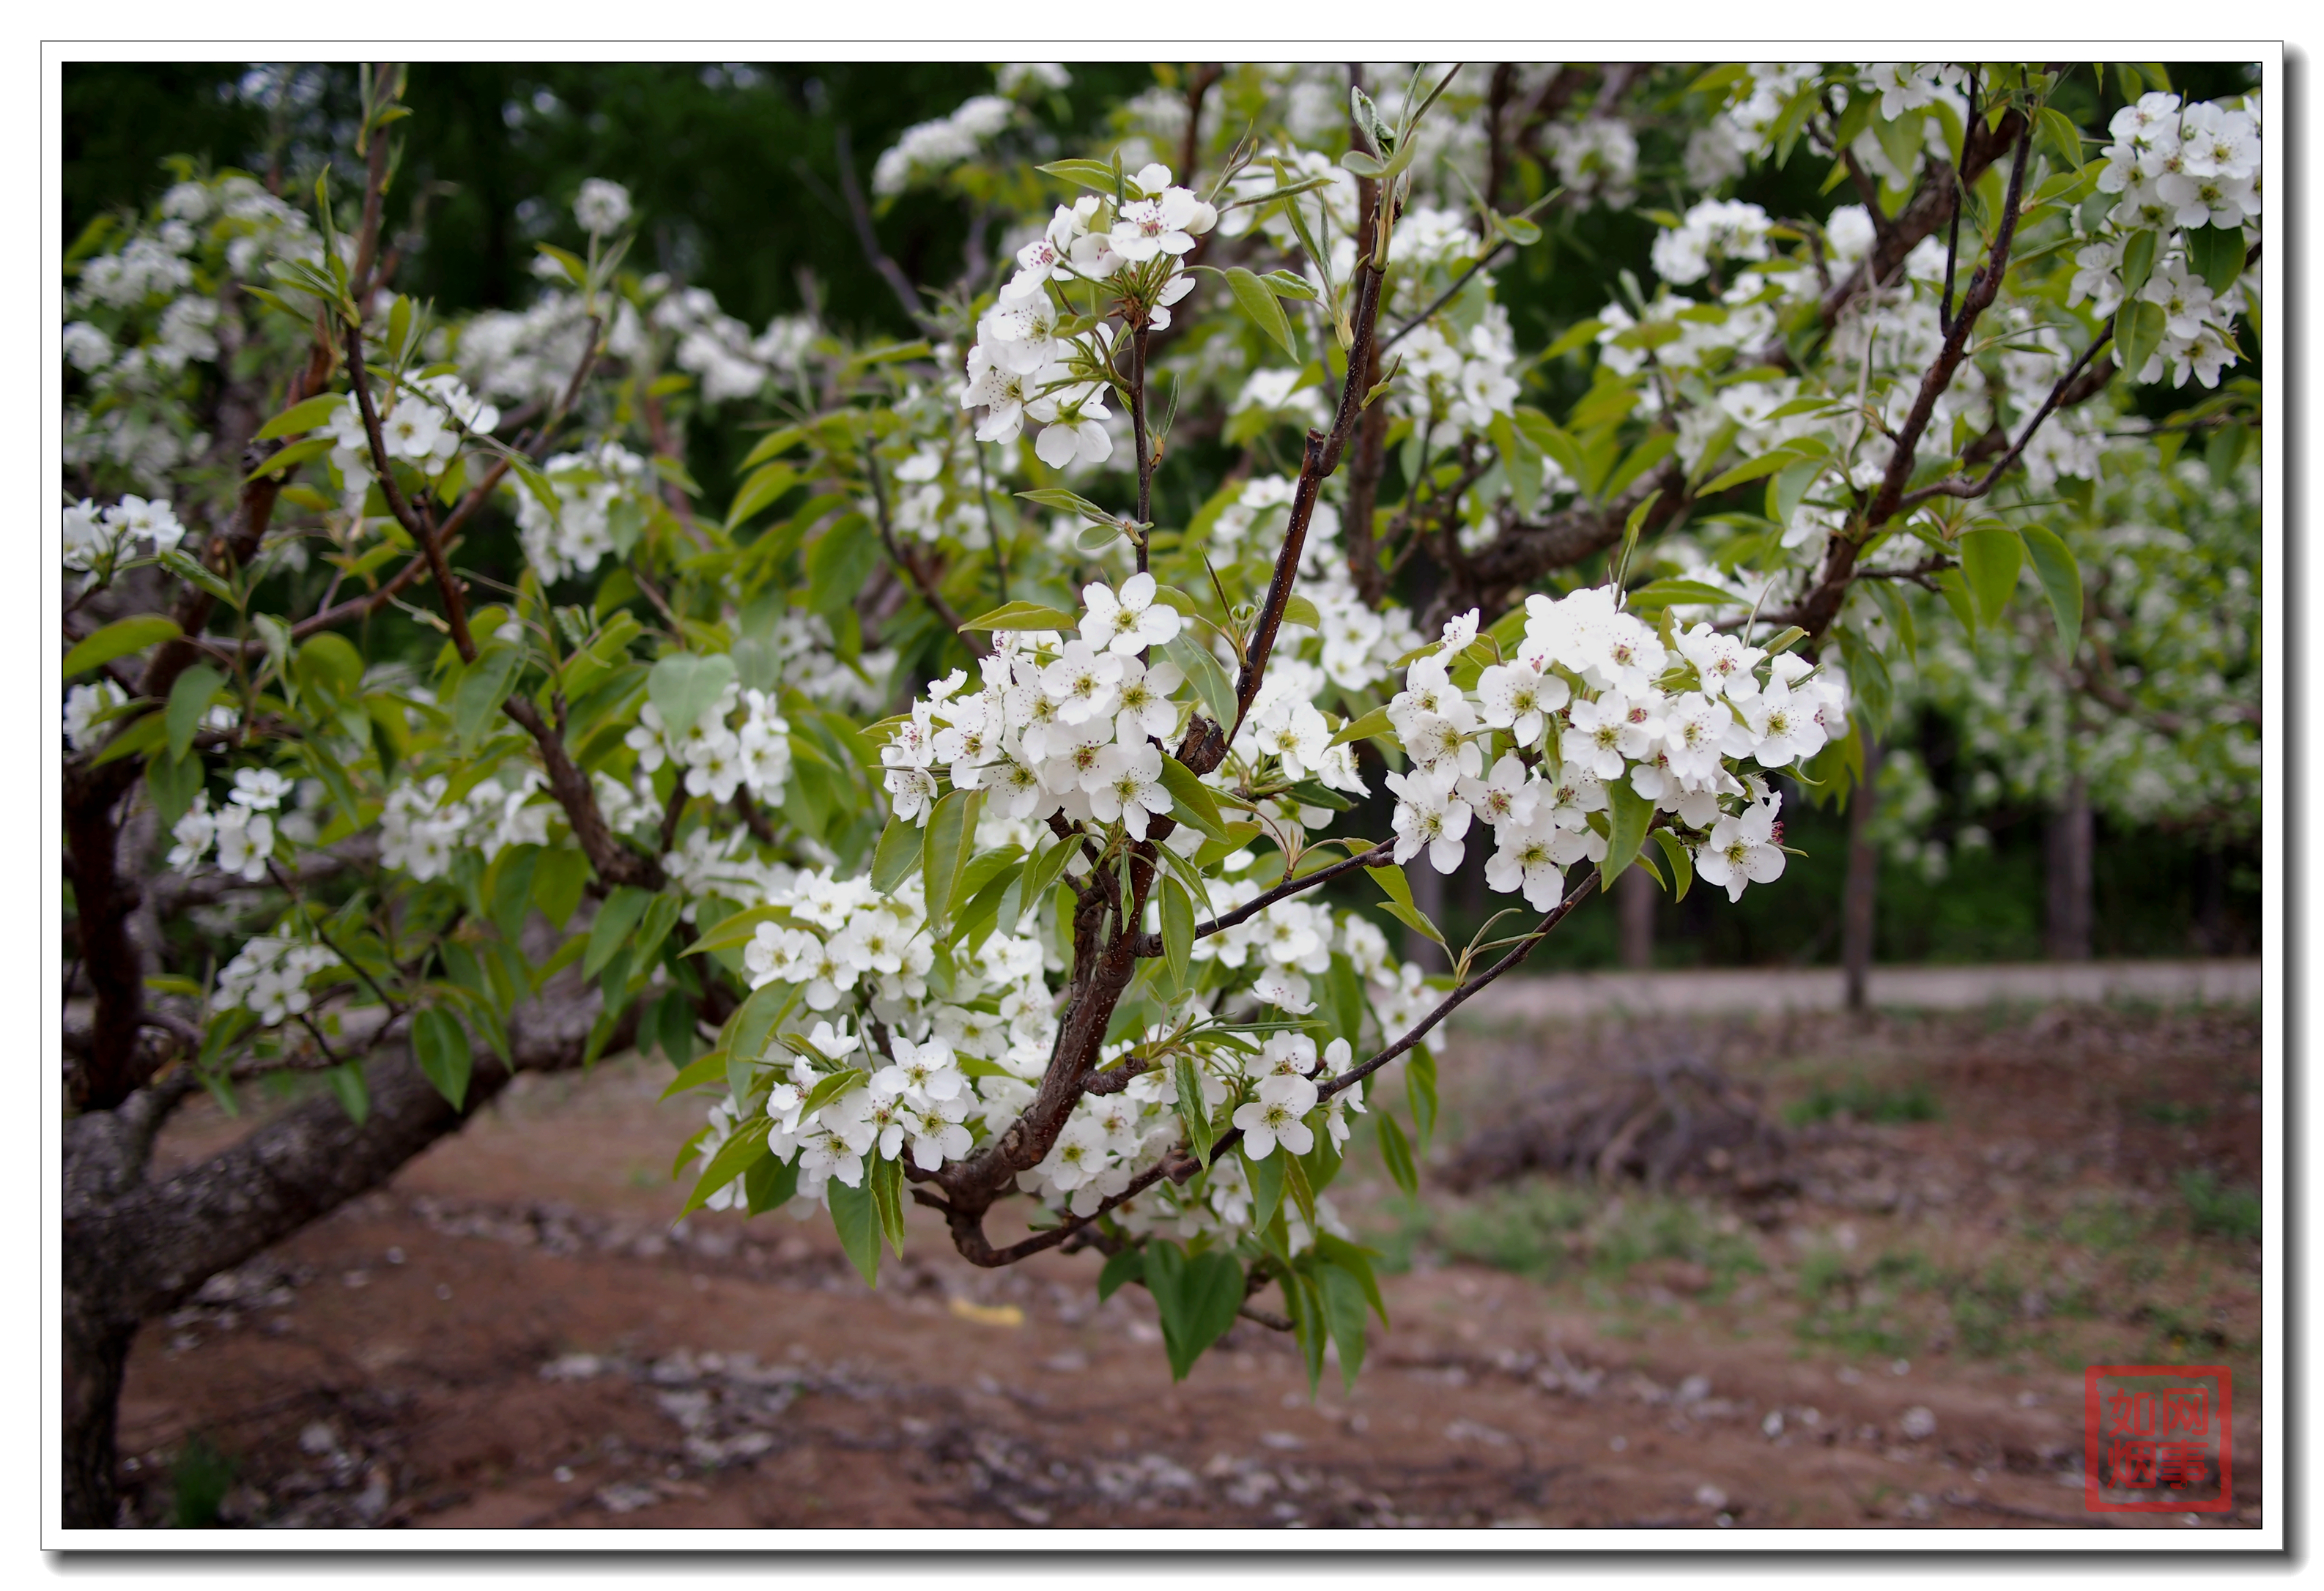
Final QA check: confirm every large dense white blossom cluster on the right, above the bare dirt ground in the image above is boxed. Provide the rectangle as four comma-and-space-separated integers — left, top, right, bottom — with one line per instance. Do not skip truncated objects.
1388, 587, 1848, 911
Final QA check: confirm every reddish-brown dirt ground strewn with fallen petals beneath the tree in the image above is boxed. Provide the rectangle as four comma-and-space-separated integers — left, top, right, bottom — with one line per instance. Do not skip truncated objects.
121, 1006, 2264, 1528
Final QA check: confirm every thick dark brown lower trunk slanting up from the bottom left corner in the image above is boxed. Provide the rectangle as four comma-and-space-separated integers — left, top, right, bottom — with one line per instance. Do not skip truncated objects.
63, 973, 634, 1528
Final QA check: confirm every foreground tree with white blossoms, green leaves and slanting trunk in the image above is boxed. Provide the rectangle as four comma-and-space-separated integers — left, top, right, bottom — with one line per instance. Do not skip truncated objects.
63, 63, 2259, 1524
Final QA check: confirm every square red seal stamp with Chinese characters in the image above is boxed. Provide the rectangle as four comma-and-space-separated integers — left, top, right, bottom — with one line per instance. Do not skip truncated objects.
2082, 1363, 2235, 1514
